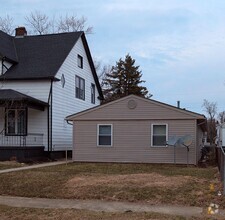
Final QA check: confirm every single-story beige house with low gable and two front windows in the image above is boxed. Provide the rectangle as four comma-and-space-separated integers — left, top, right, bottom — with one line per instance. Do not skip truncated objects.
66, 95, 206, 164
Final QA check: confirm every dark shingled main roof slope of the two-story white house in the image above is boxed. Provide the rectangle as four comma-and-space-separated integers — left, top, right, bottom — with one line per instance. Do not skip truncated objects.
0, 32, 83, 79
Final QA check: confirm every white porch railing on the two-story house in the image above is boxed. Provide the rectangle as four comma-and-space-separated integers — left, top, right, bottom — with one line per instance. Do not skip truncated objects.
0, 132, 44, 147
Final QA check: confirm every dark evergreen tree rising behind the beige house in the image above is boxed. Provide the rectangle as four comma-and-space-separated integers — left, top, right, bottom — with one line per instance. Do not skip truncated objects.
103, 54, 148, 102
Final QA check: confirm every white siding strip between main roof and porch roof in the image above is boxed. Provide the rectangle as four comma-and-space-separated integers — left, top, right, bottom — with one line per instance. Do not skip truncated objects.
0, 80, 51, 102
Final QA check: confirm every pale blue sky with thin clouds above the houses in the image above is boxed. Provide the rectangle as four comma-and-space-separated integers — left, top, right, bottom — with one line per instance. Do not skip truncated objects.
0, 0, 225, 114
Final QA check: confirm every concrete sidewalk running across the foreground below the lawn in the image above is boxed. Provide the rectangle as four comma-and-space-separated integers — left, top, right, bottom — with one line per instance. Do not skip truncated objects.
0, 196, 203, 217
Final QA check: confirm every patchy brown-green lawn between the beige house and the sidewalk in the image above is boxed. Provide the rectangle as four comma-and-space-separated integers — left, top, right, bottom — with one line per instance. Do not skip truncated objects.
0, 163, 225, 210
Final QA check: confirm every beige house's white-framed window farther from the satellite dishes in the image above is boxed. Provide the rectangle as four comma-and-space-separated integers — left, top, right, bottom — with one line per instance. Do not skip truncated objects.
97, 124, 113, 147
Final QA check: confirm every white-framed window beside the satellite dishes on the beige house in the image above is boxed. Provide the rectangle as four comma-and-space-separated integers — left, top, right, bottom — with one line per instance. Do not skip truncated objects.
151, 124, 168, 147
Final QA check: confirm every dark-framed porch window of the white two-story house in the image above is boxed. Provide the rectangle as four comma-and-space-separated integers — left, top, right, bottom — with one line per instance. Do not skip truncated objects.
5, 109, 27, 135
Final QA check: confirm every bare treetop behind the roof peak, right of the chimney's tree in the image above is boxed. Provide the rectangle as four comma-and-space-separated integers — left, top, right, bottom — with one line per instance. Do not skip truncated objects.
57, 15, 93, 34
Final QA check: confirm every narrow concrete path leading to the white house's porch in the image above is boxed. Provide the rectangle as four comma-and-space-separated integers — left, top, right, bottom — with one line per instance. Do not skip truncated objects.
0, 160, 72, 174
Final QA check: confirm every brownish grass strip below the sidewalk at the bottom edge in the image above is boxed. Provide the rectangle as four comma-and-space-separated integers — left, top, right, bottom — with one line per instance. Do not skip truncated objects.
0, 205, 222, 220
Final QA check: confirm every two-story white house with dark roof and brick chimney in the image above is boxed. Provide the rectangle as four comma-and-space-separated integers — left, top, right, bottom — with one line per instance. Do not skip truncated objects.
0, 27, 103, 159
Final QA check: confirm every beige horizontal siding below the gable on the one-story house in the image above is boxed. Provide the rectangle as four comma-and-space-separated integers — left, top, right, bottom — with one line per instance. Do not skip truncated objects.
73, 119, 196, 164
